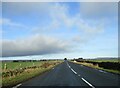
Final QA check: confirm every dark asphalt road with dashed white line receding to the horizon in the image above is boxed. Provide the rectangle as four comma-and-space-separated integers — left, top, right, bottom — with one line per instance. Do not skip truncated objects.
18, 61, 120, 88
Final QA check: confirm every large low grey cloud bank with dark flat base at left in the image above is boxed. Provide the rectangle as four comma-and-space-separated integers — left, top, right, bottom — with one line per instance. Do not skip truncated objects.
1, 35, 68, 56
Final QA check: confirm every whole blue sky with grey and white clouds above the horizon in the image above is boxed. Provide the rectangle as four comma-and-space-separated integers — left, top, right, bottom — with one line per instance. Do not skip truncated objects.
0, 2, 118, 59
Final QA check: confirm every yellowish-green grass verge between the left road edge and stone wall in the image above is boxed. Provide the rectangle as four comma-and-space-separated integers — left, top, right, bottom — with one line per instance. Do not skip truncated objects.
2, 62, 61, 87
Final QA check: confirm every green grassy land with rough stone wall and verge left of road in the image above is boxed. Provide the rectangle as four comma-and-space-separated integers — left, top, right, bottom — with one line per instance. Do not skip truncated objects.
2, 61, 62, 87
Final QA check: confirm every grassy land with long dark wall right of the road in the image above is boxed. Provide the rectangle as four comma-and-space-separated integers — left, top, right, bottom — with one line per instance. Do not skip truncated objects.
72, 59, 120, 74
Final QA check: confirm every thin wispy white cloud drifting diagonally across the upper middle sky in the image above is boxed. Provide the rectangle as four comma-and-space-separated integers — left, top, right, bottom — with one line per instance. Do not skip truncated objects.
32, 3, 105, 34
